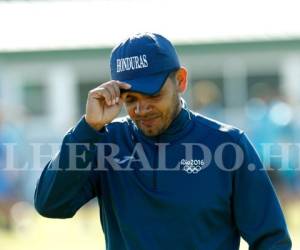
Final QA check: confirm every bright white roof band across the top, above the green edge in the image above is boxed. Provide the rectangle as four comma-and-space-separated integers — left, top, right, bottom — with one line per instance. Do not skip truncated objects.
0, 0, 300, 52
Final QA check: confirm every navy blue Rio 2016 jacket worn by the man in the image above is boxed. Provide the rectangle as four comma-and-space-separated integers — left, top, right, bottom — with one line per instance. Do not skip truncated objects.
35, 108, 291, 250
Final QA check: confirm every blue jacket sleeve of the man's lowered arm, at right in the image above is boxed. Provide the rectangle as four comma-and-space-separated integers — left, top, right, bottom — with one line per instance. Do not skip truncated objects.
233, 134, 292, 250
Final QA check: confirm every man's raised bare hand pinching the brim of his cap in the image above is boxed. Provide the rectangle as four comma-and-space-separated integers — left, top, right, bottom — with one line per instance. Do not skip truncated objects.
85, 80, 131, 130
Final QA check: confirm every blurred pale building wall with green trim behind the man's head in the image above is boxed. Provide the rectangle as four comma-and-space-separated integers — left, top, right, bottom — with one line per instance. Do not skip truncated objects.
0, 39, 300, 139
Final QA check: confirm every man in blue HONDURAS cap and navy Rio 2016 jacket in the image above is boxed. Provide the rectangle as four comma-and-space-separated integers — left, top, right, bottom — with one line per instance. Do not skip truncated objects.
35, 33, 291, 250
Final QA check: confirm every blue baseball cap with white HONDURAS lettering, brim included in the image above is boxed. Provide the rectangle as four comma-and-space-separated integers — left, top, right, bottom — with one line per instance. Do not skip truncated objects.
110, 33, 180, 95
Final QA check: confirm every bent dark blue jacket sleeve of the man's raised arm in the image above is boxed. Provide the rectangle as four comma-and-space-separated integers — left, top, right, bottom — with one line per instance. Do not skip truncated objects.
34, 118, 103, 218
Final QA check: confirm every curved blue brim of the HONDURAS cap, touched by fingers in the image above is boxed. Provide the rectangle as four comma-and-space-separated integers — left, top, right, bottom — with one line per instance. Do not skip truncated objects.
122, 72, 170, 95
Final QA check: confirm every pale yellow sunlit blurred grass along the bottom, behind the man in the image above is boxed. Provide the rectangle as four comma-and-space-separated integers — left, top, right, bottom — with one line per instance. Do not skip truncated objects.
0, 201, 300, 250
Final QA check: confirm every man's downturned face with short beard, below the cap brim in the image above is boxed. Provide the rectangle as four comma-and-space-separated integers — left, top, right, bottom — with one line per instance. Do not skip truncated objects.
124, 78, 180, 136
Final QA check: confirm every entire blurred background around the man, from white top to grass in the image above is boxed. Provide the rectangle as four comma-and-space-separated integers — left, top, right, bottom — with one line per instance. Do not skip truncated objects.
0, 0, 300, 250
